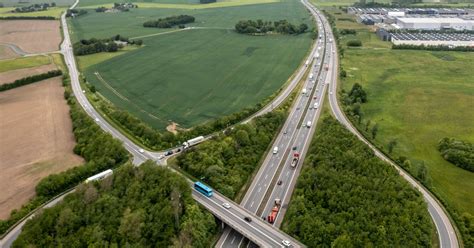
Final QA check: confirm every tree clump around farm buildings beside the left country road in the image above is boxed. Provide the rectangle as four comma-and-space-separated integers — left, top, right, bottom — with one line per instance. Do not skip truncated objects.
73, 34, 143, 56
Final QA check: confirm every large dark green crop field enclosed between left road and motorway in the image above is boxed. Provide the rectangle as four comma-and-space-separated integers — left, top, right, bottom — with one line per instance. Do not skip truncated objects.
71, 1, 313, 129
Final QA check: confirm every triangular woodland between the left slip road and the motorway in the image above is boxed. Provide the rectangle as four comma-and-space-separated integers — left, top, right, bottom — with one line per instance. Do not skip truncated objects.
177, 111, 286, 199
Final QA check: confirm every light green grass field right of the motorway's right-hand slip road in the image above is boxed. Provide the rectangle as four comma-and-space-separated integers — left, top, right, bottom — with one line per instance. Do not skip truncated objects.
322, 7, 474, 218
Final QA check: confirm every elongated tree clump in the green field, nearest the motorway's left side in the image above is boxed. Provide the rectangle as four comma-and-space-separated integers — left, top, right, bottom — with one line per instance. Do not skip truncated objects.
235, 19, 308, 34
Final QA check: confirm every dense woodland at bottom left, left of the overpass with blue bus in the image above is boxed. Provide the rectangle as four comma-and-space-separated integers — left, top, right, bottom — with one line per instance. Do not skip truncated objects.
13, 161, 217, 247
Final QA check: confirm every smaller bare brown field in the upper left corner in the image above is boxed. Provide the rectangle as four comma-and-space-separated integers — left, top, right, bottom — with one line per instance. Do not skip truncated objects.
0, 20, 61, 53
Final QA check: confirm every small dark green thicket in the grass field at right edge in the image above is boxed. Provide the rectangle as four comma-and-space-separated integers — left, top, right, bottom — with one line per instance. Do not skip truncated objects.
438, 138, 474, 172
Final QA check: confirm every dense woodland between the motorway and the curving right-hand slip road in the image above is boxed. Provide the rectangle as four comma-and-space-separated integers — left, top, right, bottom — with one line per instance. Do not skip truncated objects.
282, 117, 433, 248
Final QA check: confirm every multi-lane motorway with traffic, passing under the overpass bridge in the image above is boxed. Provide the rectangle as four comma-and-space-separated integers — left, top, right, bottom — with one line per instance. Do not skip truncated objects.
216, 2, 332, 248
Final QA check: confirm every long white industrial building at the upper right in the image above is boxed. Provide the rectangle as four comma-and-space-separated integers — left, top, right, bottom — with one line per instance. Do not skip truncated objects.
394, 17, 474, 30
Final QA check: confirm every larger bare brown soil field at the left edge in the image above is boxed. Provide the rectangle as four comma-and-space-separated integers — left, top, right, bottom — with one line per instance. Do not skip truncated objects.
0, 77, 83, 219
